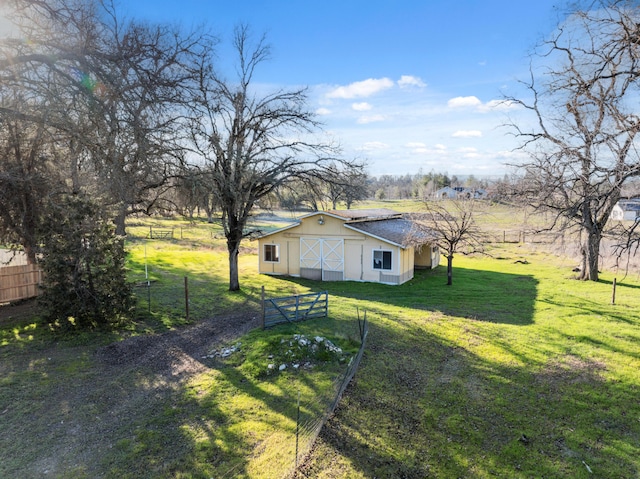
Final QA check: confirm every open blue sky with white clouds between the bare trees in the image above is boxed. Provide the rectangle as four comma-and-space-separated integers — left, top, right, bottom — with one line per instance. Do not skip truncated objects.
99, 0, 564, 176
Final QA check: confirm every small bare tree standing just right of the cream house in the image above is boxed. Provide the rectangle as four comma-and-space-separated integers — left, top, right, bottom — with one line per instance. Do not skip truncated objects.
410, 199, 485, 285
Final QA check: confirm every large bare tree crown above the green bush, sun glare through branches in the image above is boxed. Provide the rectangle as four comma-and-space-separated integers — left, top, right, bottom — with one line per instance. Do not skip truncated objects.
0, 0, 215, 234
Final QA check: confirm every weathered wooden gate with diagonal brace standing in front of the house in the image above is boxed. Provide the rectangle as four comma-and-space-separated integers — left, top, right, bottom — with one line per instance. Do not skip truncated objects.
261, 287, 329, 328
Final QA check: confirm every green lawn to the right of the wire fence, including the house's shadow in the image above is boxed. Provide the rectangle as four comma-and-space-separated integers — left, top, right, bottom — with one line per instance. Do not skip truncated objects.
303, 247, 640, 478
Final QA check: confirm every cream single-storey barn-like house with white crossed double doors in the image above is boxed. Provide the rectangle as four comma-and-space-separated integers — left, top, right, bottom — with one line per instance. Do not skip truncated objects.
258, 208, 440, 284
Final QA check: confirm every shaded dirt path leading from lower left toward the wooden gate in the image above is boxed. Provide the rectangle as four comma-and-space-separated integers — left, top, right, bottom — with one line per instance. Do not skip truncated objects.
0, 305, 260, 479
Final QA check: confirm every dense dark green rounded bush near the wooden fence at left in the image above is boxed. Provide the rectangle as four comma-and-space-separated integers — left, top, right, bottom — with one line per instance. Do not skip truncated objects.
40, 196, 134, 329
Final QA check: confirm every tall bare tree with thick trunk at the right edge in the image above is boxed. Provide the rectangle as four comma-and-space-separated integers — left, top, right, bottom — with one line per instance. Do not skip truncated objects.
509, 0, 640, 281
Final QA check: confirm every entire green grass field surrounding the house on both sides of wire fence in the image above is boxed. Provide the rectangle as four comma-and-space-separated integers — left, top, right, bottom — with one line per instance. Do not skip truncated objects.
0, 209, 640, 479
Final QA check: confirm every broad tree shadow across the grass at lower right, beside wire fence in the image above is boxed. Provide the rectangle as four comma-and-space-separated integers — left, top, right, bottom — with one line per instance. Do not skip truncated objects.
301, 318, 640, 479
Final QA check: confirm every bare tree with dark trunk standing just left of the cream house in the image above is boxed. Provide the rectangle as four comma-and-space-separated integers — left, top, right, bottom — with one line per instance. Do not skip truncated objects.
192, 26, 350, 291
